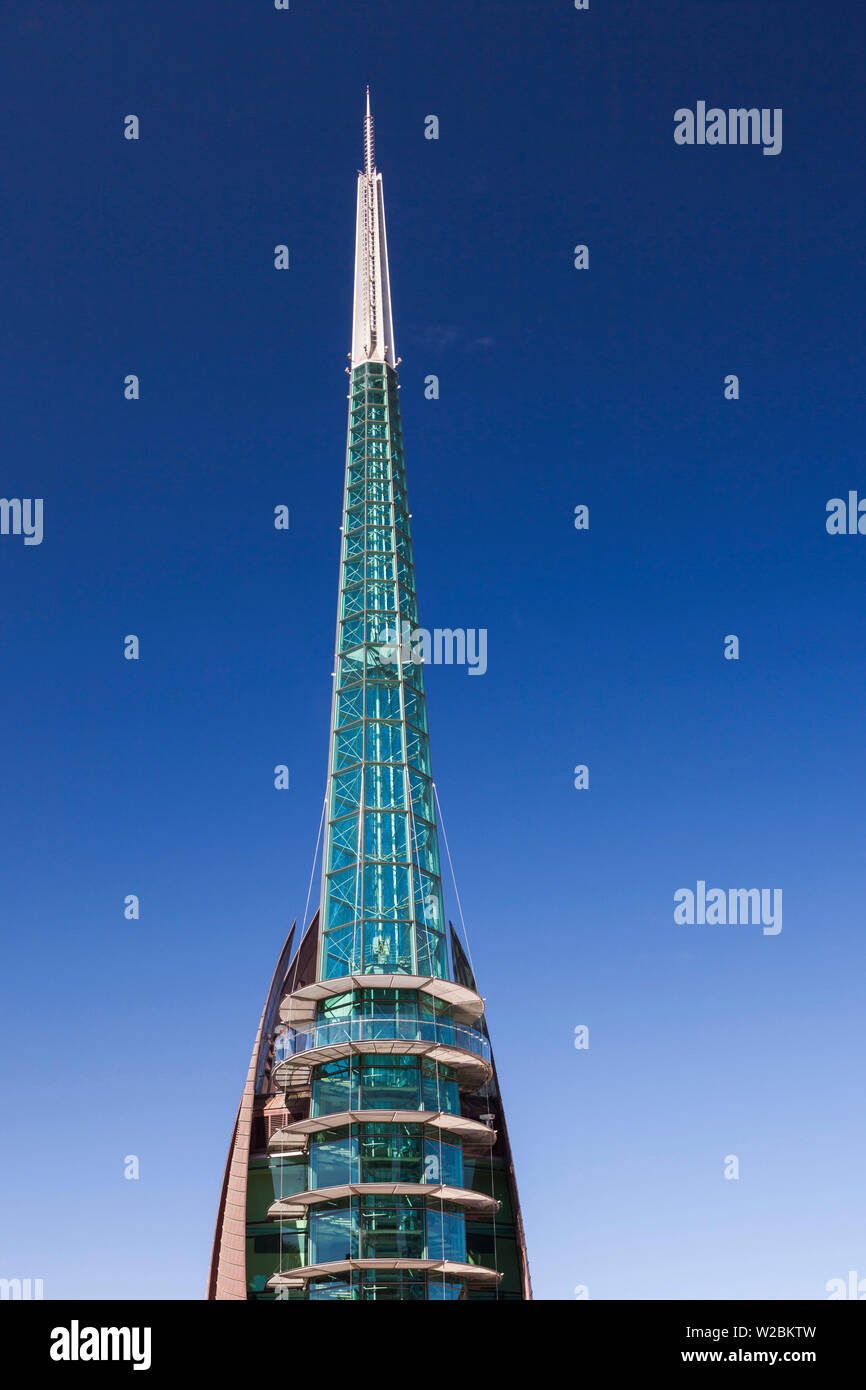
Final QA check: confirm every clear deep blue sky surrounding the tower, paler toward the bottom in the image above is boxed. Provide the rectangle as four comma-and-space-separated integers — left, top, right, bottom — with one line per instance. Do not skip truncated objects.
0, 0, 866, 1298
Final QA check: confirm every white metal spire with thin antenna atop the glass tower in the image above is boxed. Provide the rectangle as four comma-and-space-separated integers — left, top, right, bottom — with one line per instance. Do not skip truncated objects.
352, 88, 396, 367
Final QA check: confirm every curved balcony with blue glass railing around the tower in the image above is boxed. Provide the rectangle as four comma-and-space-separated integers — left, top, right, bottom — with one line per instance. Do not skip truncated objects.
272, 1017, 493, 1090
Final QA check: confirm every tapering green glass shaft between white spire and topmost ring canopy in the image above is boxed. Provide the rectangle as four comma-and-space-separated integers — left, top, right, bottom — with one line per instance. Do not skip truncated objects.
320, 361, 448, 979
